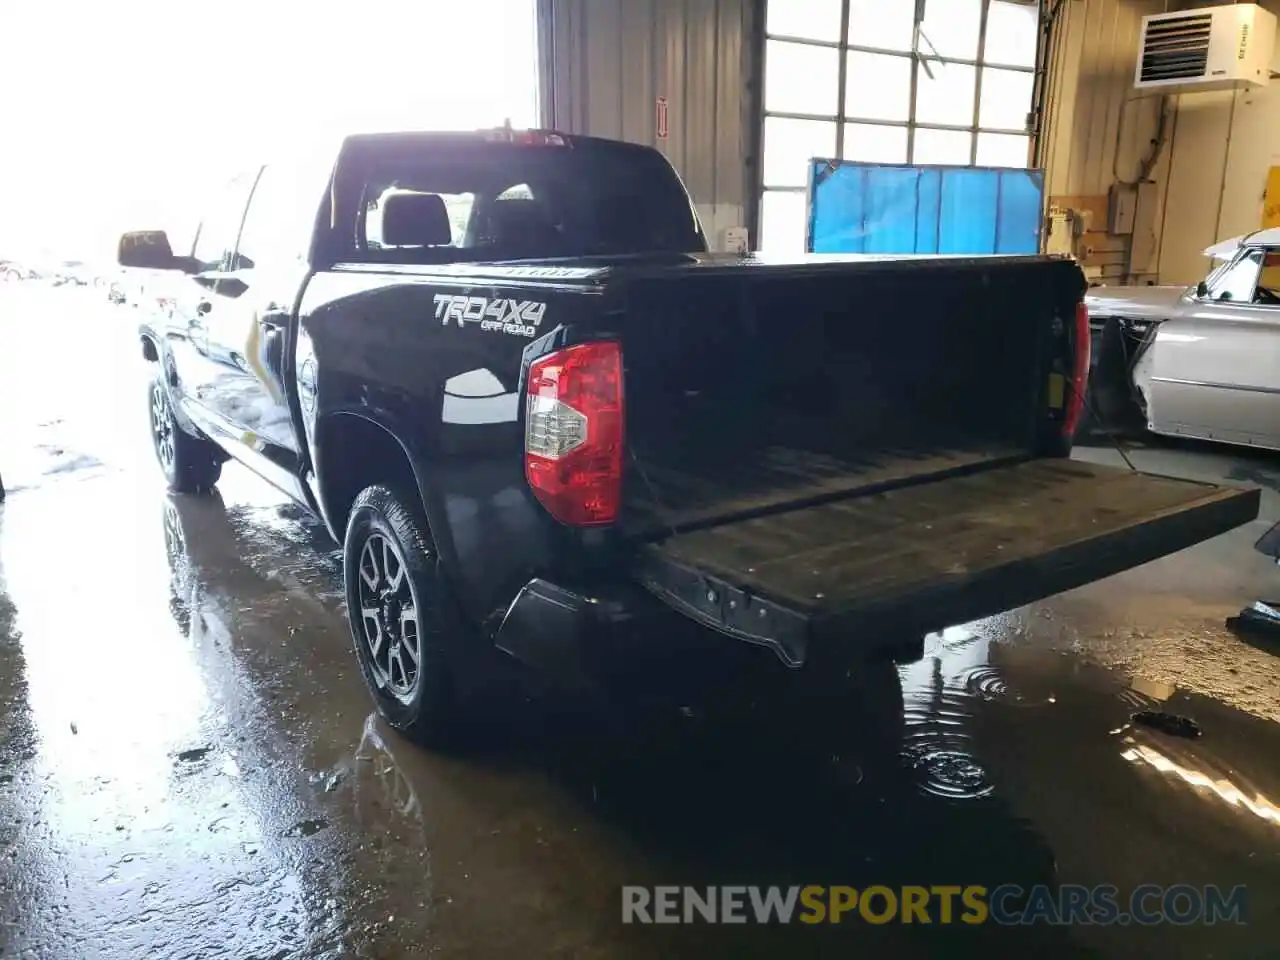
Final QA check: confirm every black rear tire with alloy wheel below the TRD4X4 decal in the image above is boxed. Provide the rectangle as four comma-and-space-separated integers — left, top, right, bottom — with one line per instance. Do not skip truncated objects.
343, 486, 462, 746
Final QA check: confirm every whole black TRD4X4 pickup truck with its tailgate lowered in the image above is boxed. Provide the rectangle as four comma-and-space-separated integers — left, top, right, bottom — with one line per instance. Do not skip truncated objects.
119, 131, 1258, 737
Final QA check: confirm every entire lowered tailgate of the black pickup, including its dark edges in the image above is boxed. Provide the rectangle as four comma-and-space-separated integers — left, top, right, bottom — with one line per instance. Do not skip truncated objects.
639, 460, 1261, 666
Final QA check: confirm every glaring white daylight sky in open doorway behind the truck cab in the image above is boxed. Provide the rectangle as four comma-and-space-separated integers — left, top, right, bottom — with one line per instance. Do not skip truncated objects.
0, 0, 538, 259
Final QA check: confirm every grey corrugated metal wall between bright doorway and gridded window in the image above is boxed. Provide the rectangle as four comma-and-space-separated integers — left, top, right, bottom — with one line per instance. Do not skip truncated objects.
538, 0, 758, 247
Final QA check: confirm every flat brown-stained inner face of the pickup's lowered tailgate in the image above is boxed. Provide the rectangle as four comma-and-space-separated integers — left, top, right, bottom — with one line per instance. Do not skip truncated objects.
649, 460, 1238, 612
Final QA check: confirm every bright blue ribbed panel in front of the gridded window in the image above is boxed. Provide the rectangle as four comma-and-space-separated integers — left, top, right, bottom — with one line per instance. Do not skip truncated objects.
806, 160, 1044, 253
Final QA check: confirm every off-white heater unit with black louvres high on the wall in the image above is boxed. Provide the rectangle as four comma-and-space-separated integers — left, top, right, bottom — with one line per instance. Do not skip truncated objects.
1134, 4, 1276, 93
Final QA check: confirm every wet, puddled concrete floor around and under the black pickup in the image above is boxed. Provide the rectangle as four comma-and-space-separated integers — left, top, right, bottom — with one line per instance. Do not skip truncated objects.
0, 284, 1280, 960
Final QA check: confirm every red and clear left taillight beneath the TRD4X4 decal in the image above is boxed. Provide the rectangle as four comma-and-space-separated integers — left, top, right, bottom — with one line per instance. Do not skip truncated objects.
525, 340, 623, 526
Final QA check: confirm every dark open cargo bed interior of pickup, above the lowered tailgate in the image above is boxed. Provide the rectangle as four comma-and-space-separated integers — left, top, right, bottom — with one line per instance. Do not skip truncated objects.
609, 260, 1080, 539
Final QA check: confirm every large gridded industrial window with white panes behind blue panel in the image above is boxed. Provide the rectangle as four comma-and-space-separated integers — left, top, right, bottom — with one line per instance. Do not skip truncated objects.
758, 0, 1039, 252
